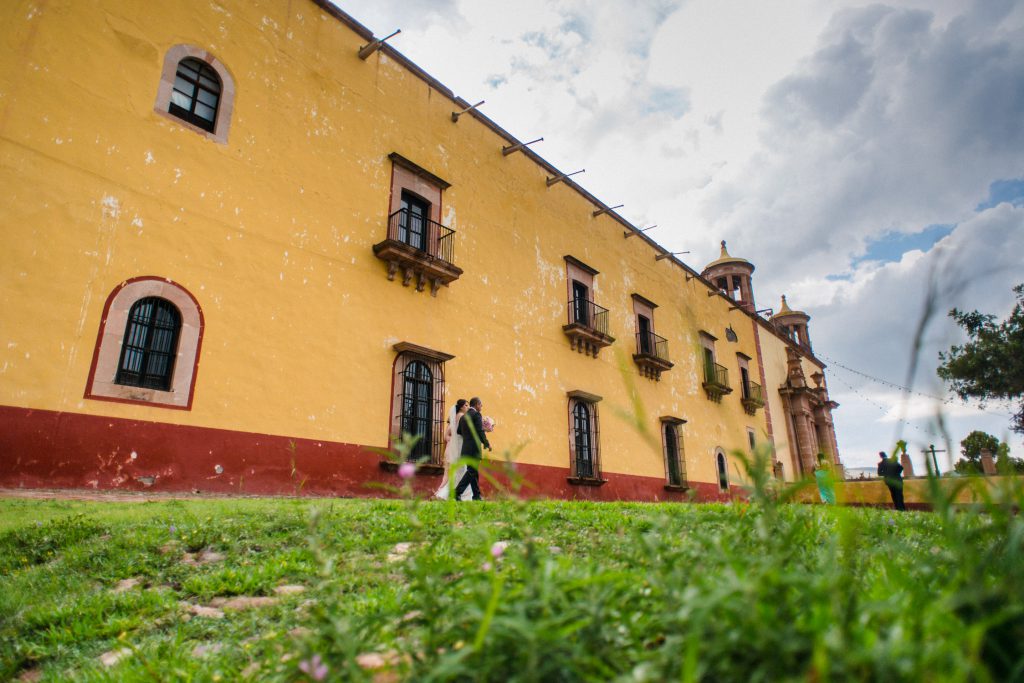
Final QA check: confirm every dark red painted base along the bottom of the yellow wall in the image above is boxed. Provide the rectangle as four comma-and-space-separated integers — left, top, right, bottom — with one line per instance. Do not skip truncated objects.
0, 407, 737, 501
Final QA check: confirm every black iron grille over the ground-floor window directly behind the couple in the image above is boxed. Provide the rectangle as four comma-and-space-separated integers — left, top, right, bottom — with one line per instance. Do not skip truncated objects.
395, 358, 444, 465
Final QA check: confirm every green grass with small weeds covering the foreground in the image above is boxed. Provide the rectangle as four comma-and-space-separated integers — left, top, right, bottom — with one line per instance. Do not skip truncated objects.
0, 477, 1024, 681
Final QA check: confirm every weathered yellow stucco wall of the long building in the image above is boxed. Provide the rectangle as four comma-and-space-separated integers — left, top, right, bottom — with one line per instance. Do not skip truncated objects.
0, 0, 815, 491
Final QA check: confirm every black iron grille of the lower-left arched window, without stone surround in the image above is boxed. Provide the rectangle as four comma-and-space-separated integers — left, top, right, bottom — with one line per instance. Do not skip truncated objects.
114, 297, 181, 391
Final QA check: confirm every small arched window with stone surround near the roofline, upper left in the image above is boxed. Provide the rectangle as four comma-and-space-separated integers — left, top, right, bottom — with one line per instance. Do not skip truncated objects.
153, 45, 234, 144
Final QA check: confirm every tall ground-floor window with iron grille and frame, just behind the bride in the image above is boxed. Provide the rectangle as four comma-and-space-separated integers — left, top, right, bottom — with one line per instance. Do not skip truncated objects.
391, 342, 455, 469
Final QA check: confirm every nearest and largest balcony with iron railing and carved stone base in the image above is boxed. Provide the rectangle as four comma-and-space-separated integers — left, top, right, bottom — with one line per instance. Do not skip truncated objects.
374, 209, 462, 296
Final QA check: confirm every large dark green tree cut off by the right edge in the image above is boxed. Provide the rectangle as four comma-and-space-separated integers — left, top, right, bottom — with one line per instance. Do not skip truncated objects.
936, 285, 1024, 434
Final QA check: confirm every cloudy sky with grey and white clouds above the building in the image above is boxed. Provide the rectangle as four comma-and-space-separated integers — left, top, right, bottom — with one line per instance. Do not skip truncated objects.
338, 0, 1024, 472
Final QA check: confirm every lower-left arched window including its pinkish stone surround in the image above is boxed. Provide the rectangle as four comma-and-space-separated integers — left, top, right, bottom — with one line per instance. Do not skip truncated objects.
85, 276, 205, 411
